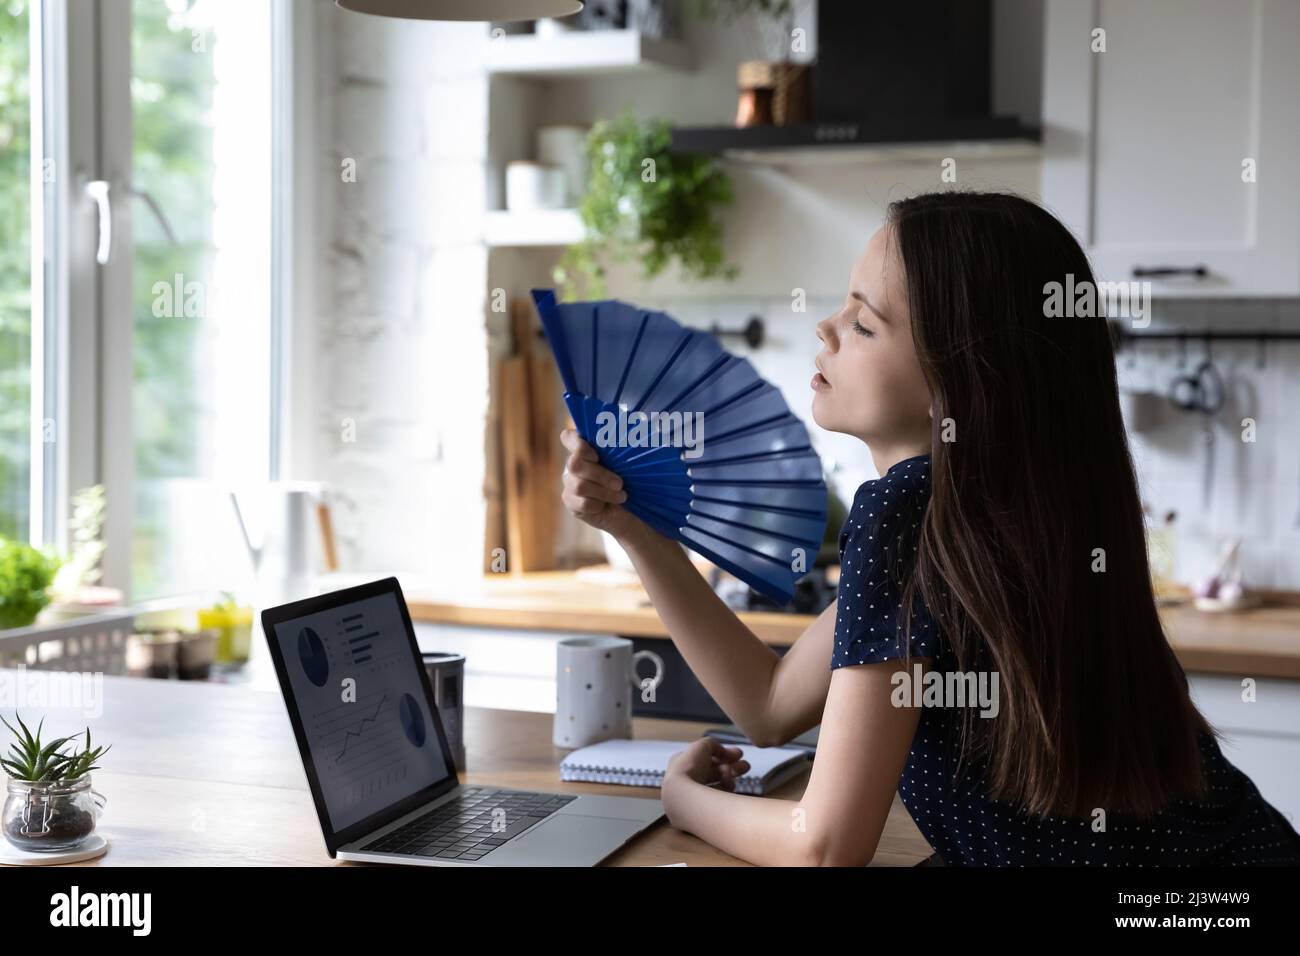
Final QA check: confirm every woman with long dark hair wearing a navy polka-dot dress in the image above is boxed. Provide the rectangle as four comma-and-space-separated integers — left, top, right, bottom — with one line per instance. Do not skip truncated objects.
562, 193, 1300, 866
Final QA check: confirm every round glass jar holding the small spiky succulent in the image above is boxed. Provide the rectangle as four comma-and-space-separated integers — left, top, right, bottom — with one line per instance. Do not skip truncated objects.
4, 774, 108, 853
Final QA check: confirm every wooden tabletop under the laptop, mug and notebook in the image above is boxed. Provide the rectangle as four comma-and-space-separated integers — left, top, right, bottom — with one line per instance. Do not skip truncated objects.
0, 670, 931, 866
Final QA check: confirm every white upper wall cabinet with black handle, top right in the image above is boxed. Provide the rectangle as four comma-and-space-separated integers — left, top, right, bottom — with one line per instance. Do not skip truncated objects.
1043, 0, 1300, 298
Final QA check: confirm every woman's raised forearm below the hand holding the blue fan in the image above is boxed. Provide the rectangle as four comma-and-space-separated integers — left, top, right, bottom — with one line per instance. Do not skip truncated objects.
619, 522, 781, 747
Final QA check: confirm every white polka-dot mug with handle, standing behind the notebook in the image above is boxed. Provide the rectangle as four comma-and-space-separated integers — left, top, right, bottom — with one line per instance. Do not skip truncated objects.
551, 637, 663, 749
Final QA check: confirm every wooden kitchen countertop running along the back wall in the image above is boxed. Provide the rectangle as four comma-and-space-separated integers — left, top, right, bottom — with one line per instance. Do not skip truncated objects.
406, 564, 1300, 680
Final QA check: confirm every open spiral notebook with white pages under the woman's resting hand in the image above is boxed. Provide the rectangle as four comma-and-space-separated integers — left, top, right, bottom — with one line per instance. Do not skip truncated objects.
560, 740, 813, 796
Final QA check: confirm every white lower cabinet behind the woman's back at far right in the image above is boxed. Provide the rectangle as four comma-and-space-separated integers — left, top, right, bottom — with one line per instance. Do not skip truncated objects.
1187, 674, 1300, 830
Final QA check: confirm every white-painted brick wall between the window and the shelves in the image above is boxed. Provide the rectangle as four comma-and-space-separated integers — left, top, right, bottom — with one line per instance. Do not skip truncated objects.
313, 7, 489, 580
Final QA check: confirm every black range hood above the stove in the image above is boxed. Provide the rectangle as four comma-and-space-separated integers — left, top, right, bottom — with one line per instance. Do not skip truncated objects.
672, 0, 1040, 160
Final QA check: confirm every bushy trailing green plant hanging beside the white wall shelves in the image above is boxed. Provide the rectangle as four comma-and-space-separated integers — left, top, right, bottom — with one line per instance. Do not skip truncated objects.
554, 109, 740, 299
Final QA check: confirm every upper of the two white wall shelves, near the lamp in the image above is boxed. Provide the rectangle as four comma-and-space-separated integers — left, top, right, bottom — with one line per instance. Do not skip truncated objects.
488, 30, 690, 79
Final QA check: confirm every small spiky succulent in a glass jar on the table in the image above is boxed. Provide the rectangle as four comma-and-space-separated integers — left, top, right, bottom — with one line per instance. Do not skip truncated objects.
0, 714, 109, 853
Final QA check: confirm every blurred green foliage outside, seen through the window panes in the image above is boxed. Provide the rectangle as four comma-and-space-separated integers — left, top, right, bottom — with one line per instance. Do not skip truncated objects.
0, 0, 215, 594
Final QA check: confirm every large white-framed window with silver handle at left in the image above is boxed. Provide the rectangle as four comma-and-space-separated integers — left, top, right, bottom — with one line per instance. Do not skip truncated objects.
0, 0, 291, 598
